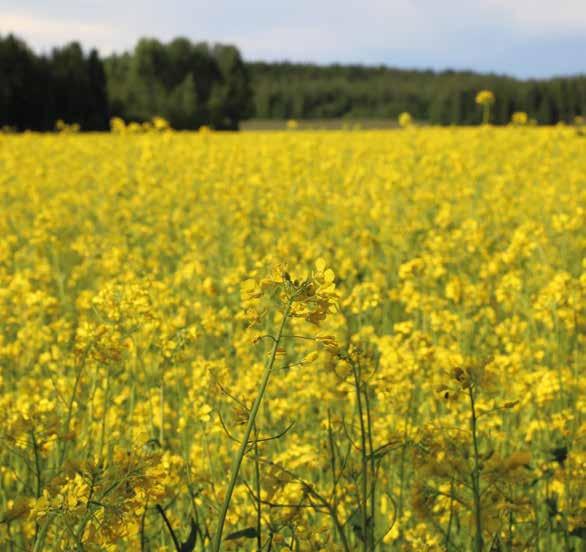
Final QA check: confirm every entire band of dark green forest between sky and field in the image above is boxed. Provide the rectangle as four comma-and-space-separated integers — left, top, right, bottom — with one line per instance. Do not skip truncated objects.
0, 35, 586, 130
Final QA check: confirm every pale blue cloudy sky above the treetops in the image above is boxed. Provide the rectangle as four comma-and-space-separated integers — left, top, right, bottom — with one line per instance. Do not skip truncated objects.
0, 0, 586, 78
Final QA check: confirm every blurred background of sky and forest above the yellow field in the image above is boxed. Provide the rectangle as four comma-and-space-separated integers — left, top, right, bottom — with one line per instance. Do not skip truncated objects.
0, 0, 586, 130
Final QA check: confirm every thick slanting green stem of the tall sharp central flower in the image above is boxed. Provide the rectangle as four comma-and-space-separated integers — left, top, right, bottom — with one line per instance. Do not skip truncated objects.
212, 300, 291, 552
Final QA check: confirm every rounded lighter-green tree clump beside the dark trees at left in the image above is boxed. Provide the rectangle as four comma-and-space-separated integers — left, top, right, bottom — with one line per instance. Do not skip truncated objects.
105, 38, 254, 130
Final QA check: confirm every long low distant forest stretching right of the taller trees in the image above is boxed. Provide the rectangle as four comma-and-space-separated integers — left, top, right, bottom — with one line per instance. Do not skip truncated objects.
248, 62, 586, 125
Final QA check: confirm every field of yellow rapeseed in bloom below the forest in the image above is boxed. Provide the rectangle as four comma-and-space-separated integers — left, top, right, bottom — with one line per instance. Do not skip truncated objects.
0, 124, 586, 552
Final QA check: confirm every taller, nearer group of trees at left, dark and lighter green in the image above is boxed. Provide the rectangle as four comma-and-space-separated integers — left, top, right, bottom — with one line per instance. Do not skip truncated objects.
0, 35, 254, 130
